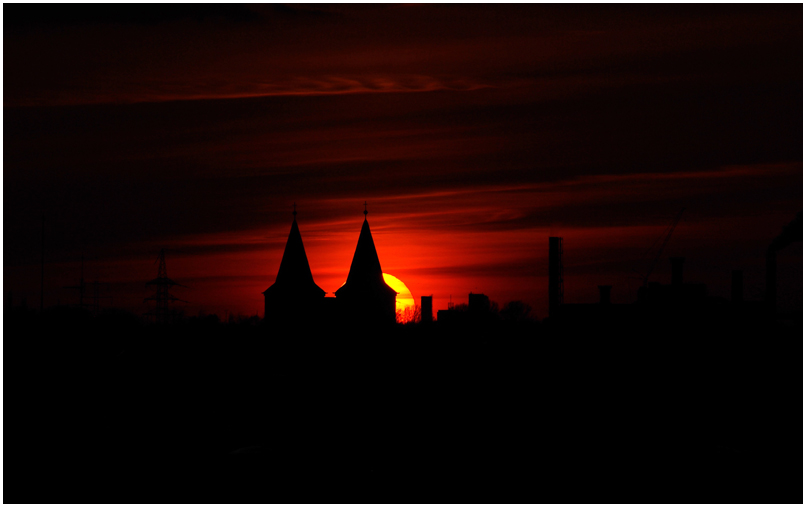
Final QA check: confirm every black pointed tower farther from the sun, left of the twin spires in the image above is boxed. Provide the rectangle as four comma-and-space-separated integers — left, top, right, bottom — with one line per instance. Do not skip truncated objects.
263, 209, 325, 322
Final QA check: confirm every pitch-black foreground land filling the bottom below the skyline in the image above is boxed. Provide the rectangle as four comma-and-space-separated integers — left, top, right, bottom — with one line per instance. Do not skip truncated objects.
4, 308, 803, 503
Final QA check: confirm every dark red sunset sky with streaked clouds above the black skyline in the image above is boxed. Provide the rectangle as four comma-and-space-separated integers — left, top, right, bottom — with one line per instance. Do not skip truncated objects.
3, 4, 803, 318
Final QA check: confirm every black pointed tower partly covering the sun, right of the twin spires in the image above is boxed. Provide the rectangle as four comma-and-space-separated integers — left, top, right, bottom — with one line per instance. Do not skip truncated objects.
336, 209, 397, 324
